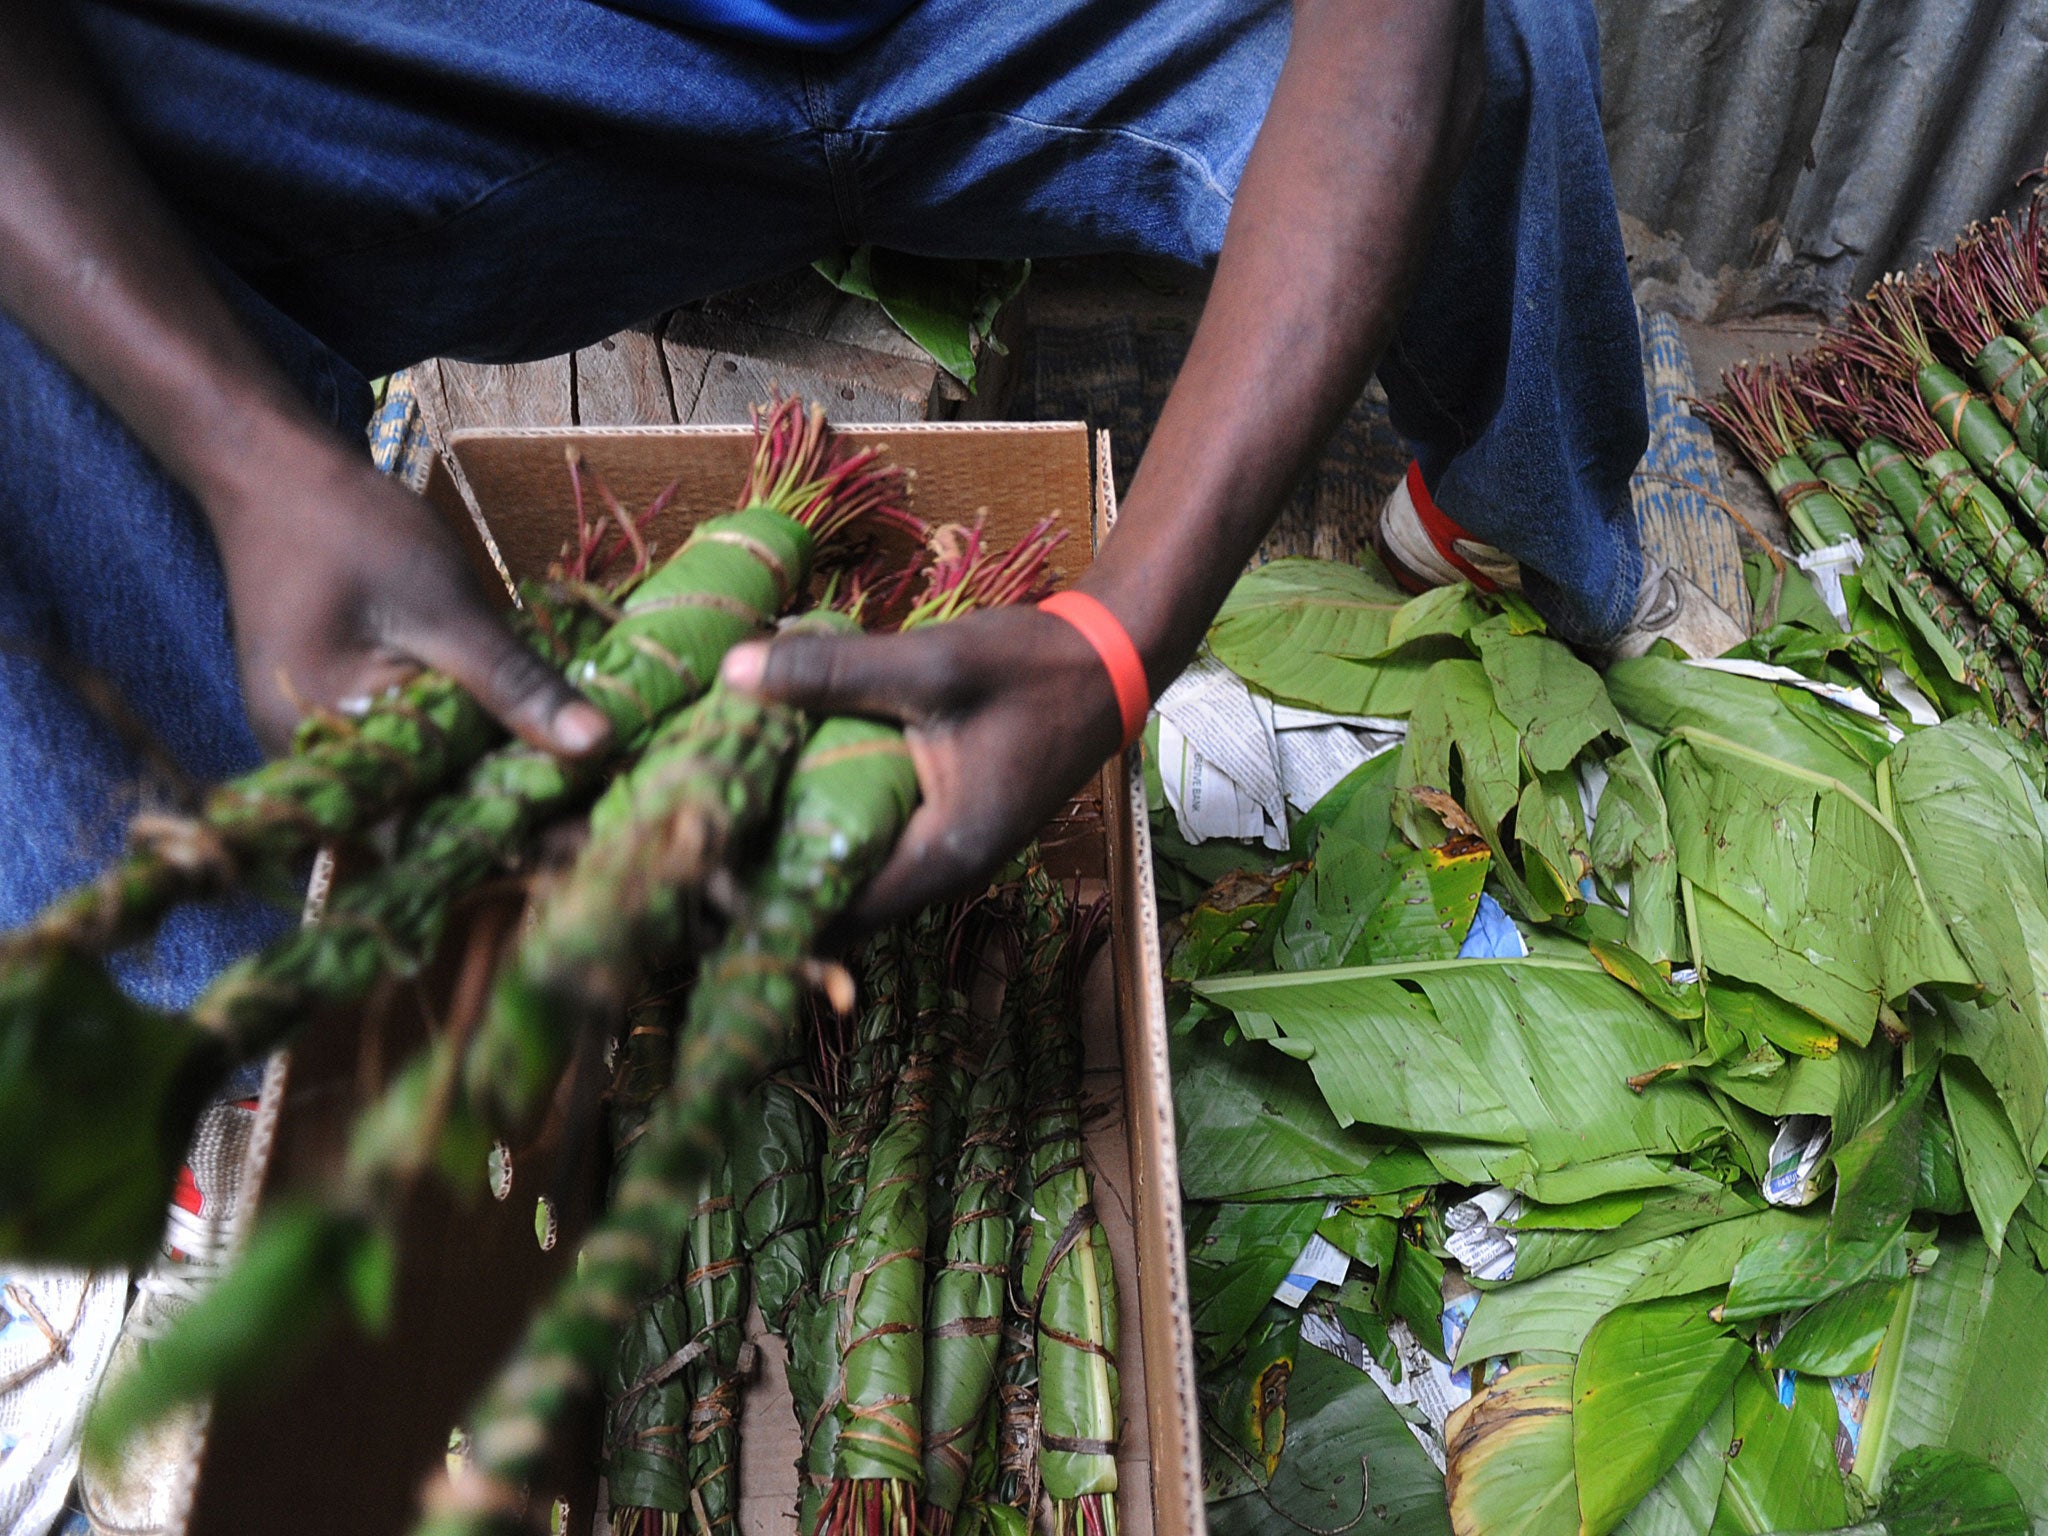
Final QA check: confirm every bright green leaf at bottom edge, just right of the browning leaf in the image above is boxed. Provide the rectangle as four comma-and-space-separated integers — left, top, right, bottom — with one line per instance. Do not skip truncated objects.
1571, 1292, 1749, 1536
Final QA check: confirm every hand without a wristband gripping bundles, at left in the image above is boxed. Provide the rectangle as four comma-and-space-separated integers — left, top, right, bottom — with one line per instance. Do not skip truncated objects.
209, 442, 606, 758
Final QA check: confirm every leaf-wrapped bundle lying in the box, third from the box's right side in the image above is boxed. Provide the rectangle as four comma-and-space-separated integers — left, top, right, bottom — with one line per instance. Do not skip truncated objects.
823, 913, 944, 1536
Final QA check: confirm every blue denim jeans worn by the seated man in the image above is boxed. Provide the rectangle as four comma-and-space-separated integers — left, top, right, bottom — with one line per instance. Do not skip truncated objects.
0, 0, 1647, 1006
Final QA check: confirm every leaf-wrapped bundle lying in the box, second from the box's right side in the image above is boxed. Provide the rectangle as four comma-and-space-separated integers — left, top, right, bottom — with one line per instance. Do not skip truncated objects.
920, 999, 1022, 1536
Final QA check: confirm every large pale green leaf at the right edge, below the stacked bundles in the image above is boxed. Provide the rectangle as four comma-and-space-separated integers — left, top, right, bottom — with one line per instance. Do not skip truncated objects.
1892, 721, 2048, 1165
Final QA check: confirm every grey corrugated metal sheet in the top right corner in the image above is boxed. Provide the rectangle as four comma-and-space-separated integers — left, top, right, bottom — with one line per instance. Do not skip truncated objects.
1595, 0, 2048, 319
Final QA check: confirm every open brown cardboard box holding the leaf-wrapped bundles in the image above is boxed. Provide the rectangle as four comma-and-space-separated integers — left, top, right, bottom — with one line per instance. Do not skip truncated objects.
172, 424, 1204, 1536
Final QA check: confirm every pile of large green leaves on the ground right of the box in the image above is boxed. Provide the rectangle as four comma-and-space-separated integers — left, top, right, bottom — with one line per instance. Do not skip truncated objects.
1157, 561, 2048, 1536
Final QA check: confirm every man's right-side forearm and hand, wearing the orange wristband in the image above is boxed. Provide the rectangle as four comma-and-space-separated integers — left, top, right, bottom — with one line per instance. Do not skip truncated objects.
725, 0, 1483, 924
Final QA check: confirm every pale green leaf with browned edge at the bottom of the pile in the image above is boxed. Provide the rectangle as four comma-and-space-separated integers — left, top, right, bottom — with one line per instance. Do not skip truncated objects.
1444, 1366, 1579, 1536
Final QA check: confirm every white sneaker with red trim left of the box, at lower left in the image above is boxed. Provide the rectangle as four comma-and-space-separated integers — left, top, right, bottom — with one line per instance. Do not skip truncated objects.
78, 1098, 256, 1536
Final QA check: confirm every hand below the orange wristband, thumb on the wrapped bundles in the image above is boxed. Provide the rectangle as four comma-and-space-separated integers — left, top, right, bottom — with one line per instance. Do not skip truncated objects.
723, 608, 1122, 930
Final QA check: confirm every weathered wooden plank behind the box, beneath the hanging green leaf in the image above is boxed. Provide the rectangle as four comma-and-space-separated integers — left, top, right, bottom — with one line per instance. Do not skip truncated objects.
662, 309, 940, 426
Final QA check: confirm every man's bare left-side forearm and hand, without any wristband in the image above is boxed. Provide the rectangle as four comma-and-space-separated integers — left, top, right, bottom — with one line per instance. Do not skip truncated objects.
0, 0, 604, 754
